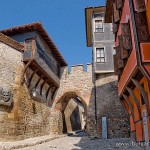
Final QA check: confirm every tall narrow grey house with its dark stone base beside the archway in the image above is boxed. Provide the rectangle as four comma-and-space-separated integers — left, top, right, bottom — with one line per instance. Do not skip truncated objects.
85, 6, 129, 138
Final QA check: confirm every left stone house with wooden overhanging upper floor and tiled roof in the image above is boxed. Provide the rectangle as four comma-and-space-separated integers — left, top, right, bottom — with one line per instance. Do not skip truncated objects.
0, 23, 67, 140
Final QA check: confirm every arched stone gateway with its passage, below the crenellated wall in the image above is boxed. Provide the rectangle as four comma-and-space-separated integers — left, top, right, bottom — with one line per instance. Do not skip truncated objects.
52, 90, 87, 134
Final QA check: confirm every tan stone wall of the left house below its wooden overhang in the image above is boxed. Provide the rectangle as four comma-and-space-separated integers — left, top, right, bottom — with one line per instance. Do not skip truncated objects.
0, 43, 51, 141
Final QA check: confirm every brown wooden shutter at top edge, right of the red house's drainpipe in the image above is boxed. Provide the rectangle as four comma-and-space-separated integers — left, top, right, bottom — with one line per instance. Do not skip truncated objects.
133, 0, 146, 12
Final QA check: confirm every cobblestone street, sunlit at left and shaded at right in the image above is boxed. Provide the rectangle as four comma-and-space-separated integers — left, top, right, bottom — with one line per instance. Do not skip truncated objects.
18, 133, 143, 150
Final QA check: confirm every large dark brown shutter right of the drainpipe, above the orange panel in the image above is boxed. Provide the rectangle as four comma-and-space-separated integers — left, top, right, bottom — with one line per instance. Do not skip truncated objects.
135, 12, 150, 42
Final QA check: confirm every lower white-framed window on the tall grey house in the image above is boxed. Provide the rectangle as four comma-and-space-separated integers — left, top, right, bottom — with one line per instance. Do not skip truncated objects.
96, 48, 105, 63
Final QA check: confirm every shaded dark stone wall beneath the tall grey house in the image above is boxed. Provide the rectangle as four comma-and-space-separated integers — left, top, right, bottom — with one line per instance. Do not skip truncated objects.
87, 73, 129, 138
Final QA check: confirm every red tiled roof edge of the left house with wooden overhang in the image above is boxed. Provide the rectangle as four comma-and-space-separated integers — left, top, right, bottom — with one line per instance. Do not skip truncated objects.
0, 22, 67, 66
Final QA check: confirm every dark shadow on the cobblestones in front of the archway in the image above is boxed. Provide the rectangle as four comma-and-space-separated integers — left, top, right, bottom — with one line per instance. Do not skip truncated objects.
70, 132, 144, 150
